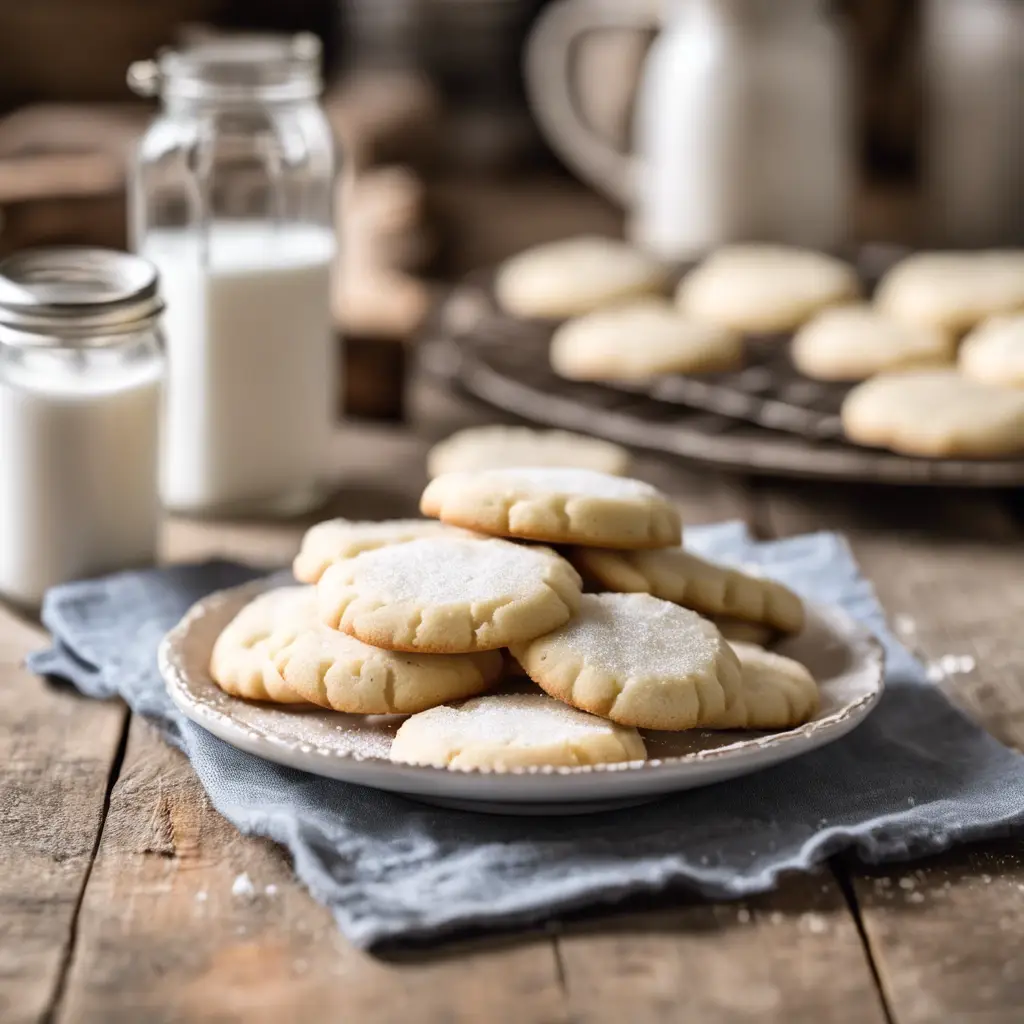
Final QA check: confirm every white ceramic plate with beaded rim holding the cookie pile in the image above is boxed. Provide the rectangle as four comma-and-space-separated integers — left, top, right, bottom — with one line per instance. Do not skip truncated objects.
160, 582, 884, 814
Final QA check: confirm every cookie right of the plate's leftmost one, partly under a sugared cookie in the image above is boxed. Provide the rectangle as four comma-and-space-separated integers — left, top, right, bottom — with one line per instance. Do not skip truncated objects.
273, 624, 502, 715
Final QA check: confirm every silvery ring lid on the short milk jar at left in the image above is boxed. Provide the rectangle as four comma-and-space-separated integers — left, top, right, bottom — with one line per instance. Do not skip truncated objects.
0, 246, 164, 346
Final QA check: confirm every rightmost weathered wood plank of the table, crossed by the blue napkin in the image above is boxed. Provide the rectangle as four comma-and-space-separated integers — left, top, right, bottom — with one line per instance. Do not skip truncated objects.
767, 488, 1024, 1024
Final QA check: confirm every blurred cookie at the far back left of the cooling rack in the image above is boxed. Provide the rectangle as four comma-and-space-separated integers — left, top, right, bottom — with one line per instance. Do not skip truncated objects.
495, 234, 666, 319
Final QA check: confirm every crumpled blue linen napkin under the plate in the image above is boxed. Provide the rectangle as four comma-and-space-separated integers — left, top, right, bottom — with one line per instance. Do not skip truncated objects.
29, 523, 1024, 947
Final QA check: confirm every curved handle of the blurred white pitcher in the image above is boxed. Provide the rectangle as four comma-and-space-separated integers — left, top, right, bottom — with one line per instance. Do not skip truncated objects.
523, 0, 658, 207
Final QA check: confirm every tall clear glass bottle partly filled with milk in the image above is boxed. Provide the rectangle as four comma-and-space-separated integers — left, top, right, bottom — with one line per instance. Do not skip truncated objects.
128, 35, 337, 514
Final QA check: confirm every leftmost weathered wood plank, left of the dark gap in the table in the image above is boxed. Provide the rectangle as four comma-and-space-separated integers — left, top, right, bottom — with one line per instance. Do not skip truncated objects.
0, 610, 126, 1024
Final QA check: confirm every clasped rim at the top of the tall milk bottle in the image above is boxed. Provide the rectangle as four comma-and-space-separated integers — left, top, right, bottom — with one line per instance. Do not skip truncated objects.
128, 32, 323, 102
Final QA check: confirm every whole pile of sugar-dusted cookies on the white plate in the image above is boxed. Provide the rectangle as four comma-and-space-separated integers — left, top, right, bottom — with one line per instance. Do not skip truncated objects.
211, 467, 818, 770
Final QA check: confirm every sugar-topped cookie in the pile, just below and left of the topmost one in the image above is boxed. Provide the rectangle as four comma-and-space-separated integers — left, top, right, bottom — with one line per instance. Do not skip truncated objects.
317, 537, 581, 654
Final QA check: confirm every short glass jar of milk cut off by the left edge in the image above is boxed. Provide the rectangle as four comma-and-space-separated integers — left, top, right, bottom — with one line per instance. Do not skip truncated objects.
0, 248, 164, 607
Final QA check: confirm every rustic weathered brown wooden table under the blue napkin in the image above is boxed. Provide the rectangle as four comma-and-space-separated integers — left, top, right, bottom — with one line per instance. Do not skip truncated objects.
0, 378, 1024, 1024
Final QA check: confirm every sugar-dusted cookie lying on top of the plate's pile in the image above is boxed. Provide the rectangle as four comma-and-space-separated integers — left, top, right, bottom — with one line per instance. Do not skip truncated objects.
420, 467, 682, 549
